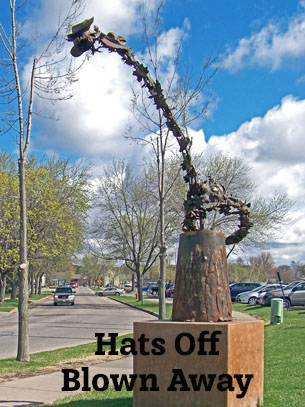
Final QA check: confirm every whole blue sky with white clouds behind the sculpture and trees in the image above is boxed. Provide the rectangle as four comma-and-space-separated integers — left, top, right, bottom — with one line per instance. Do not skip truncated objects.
0, 0, 305, 265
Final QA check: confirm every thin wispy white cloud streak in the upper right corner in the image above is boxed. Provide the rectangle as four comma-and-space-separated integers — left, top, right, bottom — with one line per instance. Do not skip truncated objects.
222, 6, 305, 72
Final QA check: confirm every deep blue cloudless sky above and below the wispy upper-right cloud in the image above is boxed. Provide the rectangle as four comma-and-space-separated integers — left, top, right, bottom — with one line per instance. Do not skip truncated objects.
158, 0, 305, 137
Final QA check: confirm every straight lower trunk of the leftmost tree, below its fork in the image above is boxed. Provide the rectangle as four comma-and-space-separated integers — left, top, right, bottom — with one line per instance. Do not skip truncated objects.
17, 159, 30, 362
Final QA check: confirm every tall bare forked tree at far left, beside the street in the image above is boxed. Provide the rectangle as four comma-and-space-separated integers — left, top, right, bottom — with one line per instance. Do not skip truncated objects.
0, 0, 82, 362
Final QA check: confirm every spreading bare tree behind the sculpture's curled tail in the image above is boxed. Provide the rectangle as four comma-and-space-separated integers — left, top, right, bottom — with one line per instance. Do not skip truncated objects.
196, 153, 293, 255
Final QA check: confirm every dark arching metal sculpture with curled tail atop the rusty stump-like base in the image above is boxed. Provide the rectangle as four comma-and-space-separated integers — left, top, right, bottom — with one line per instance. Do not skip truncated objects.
67, 17, 252, 245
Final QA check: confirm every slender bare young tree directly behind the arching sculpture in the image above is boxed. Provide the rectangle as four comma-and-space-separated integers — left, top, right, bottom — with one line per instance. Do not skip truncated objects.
130, 0, 217, 319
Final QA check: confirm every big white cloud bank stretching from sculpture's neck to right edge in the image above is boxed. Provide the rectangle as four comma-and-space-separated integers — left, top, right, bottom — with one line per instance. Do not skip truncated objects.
190, 96, 305, 264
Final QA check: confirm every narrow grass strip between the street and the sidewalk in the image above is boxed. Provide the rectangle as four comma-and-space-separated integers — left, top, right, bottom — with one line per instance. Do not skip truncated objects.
0, 335, 132, 382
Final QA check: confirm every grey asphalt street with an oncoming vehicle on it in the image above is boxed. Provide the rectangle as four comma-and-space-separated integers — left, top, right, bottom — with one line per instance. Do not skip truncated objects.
0, 287, 155, 359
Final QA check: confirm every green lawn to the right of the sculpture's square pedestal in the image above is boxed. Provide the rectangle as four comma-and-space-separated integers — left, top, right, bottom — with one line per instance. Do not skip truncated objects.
233, 304, 305, 407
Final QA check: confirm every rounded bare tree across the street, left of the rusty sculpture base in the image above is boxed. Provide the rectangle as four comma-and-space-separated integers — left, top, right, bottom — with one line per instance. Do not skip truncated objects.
91, 161, 159, 300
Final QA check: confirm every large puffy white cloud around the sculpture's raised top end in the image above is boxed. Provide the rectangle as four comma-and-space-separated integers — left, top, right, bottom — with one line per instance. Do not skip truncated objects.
23, 0, 190, 158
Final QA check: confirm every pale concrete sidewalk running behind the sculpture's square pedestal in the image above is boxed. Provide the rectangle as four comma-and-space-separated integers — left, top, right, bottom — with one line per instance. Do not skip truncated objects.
0, 294, 255, 407
